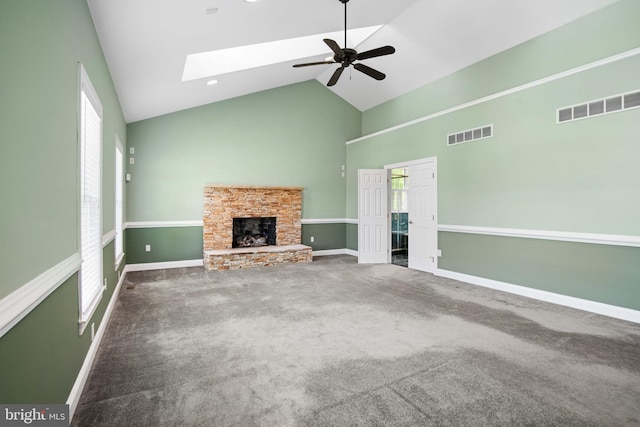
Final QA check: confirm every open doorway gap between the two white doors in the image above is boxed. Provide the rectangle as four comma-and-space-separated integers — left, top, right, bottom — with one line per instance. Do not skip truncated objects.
390, 168, 409, 267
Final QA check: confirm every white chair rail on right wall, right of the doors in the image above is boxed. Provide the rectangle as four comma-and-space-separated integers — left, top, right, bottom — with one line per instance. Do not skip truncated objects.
438, 224, 640, 247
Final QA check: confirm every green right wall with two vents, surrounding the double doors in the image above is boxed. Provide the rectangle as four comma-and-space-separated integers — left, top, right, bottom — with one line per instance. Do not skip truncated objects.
347, 0, 640, 309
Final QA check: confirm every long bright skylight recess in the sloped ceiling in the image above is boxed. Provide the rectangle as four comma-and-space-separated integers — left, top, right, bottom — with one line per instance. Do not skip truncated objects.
182, 25, 382, 82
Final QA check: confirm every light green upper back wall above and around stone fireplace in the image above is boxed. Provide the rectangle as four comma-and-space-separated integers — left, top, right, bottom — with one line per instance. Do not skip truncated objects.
127, 80, 361, 222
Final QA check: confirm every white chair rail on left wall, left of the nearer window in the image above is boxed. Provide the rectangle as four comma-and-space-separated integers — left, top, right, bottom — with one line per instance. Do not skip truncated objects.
0, 253, 82, 337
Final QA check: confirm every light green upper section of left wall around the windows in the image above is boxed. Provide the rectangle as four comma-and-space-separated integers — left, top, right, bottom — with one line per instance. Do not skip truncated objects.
0, 0, 126, 298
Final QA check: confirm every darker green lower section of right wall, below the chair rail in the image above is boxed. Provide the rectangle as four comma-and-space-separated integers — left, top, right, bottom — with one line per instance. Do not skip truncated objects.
438, 233, 640, 310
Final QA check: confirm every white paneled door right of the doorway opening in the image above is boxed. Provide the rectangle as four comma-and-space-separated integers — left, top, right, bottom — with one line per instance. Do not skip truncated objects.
408, 162, 438, 273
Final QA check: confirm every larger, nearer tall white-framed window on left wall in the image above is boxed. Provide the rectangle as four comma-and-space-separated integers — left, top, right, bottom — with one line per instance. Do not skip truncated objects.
78, 65, 102, 333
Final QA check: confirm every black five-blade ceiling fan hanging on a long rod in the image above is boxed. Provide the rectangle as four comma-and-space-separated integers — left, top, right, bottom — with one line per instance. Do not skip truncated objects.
294, 0, 396, 86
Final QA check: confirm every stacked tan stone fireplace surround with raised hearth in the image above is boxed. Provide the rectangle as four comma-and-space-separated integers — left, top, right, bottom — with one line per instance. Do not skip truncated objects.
203, 185, 312, 270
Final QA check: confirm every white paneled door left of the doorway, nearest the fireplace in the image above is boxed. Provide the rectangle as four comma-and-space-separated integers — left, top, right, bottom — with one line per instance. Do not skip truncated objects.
358, 169, 391, 264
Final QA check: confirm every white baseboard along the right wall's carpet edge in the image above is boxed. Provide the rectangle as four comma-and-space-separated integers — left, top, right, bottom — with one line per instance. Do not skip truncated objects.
435, 269, 640, 323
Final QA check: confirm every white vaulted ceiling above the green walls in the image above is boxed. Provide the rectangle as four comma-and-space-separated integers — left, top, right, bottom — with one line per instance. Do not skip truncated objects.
88, 0, 617, 122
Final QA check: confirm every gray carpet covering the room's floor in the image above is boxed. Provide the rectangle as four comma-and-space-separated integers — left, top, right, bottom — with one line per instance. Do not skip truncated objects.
72, 256, 640, 427
